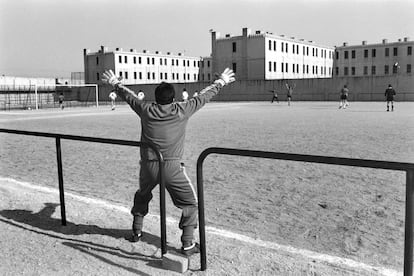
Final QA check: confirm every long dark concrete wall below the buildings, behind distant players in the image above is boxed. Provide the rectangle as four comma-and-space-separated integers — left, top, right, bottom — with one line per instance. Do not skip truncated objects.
99, 76, 414, 101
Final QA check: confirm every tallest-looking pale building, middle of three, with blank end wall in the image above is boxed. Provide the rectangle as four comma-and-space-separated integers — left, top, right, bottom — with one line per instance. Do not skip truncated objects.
211, 28, 335, 80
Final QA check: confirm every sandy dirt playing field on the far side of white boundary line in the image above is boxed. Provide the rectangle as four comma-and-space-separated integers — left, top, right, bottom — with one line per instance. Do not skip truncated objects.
0, 102, 414, 275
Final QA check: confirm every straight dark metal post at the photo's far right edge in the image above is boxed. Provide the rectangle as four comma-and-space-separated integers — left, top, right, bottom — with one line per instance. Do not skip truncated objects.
404, 170, 414, 276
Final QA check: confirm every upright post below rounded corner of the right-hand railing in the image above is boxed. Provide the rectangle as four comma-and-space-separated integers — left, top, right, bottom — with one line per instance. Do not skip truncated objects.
197, 156, 207, 271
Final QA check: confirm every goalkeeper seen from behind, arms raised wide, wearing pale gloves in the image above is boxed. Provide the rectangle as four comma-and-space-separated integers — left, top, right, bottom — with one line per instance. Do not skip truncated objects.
102, 68, 235, 256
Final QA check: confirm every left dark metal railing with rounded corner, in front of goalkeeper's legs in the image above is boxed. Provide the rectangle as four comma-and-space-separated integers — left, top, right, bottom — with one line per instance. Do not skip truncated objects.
0, 128, 167, 254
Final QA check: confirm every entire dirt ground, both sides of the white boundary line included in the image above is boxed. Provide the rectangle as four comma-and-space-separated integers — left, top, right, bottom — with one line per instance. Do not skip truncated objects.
0, 102, 414, 275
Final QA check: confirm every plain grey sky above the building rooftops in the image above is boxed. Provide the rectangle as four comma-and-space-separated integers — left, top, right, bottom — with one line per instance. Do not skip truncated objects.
0, 0, 414, 78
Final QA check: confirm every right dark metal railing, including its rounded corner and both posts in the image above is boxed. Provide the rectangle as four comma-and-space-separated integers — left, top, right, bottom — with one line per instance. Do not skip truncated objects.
197, 147, 414, 276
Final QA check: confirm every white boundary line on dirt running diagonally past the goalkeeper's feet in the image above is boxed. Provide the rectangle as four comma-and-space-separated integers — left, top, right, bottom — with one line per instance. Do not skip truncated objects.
0, 177, 402, 276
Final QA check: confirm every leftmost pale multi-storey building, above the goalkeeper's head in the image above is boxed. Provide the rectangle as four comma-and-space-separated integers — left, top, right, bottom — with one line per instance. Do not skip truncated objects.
83, 46, 205, 85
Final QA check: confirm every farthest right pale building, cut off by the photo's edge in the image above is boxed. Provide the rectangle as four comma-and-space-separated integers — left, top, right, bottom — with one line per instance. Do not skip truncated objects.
334, 37, 414, 77
